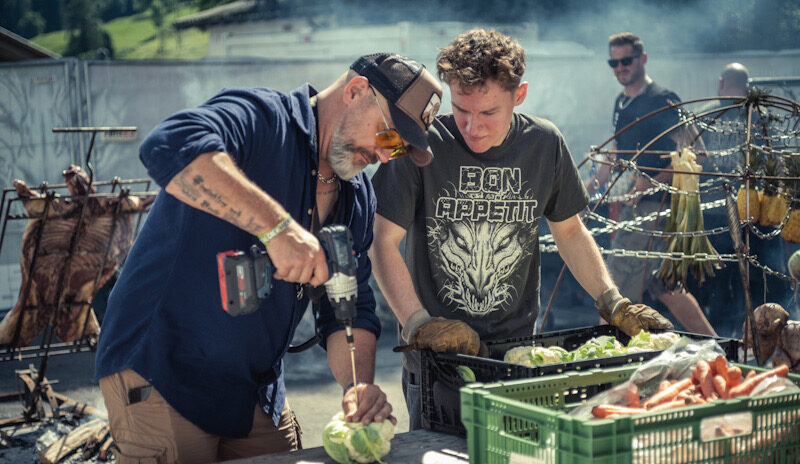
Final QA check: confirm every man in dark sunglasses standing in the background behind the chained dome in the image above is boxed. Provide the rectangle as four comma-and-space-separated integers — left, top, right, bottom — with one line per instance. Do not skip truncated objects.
587, 32, 716, 335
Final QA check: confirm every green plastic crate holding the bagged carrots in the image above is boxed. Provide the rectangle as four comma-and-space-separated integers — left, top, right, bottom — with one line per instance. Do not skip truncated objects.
460, 364, 800, 464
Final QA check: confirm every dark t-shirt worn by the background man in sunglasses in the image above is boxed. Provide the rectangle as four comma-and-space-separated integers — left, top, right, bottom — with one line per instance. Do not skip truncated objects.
612, 82, 681, 169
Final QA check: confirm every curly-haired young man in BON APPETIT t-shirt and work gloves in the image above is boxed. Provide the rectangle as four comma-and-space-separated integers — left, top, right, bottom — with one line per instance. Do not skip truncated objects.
370, 29, 671, 429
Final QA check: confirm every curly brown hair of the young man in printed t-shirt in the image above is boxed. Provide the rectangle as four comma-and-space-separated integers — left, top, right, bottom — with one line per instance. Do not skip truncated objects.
436, 29, 525, 91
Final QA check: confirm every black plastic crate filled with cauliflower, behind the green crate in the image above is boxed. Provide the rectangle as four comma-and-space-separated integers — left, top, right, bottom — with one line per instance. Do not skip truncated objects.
420, 325, 740, 436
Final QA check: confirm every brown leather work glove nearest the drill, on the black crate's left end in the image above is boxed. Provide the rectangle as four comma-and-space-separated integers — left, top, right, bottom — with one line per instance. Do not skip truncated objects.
394, 309, 489, 357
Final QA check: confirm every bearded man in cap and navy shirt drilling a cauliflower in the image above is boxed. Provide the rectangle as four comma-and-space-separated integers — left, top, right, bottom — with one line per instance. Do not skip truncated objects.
96, 54, 441, 462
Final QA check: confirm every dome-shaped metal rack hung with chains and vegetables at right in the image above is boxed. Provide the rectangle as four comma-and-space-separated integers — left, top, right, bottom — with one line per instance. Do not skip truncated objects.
539, 89, 800, 364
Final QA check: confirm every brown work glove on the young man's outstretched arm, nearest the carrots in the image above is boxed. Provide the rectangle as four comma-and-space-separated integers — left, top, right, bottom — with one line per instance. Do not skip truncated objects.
594, 288, 675, 337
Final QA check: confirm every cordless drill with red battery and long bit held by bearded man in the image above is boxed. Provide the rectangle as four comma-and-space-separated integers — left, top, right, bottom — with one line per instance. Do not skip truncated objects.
217, 224, 358, 400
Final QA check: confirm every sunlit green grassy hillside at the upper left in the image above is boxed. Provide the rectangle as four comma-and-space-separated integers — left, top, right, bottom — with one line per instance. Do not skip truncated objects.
31, 6, 208, 60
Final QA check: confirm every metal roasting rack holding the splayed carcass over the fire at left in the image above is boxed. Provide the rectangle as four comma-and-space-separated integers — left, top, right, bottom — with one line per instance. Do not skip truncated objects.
0, 127, 156, 427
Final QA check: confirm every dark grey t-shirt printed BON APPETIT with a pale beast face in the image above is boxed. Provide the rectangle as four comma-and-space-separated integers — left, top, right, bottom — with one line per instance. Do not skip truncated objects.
372, 114, 587, 339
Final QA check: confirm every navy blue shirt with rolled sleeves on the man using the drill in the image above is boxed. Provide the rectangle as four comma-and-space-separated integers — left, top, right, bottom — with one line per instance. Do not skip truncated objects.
95, 85, 380, 438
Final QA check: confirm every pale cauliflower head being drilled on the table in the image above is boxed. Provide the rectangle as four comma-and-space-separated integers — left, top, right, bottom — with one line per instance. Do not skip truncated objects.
322, 412, 394, 464
